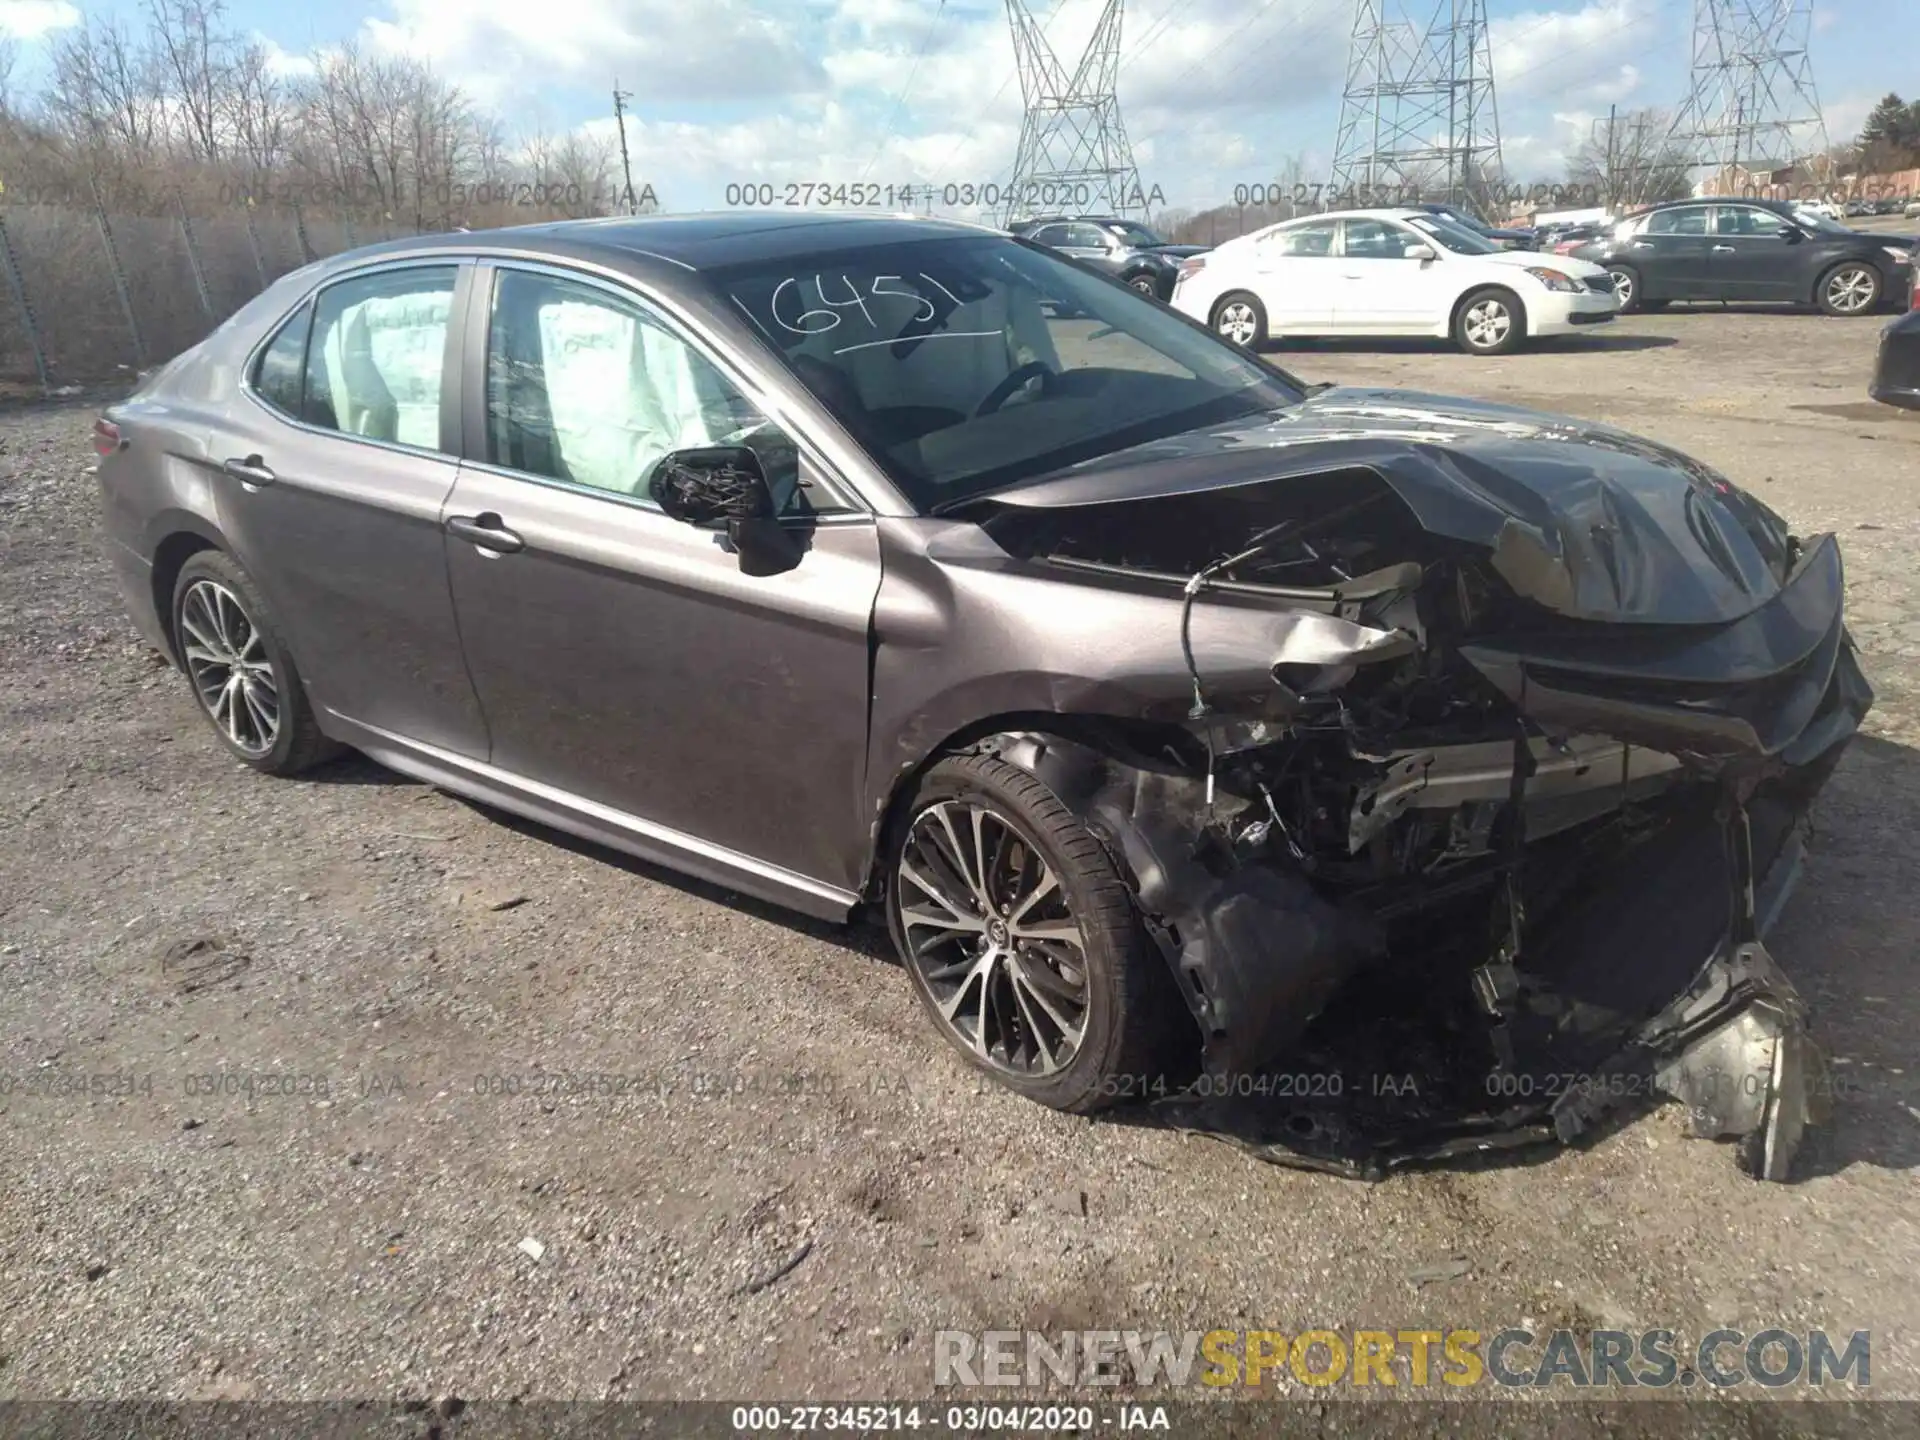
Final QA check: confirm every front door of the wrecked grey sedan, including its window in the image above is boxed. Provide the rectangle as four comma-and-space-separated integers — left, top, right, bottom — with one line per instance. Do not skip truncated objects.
445, 267, 879, 891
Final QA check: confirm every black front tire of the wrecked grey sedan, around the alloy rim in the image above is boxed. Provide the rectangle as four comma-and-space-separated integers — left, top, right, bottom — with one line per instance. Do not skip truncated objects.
887, 755, 1198, 1114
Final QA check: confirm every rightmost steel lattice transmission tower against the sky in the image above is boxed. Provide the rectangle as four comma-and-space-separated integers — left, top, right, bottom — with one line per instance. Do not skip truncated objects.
1672, 0, 1828, 184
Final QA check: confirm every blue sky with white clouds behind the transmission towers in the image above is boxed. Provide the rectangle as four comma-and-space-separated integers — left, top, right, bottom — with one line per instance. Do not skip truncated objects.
0, 0, 1920, 209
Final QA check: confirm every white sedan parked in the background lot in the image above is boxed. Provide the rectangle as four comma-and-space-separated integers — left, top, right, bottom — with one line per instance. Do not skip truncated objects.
1171, 209, 1620, 355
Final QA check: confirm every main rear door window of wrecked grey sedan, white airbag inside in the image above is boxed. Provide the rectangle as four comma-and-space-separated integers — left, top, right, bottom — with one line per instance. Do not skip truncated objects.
301, 265, 457, 449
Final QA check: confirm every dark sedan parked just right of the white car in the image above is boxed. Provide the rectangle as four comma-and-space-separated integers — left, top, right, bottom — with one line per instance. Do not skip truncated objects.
1574, 198, 1912, 315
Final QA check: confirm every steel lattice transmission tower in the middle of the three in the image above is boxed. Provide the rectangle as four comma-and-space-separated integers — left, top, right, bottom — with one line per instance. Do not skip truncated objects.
1329, 0, 1501, 215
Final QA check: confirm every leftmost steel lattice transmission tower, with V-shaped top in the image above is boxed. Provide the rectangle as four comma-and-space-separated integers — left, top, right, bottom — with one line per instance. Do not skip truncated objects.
1000, 0, 1148, 223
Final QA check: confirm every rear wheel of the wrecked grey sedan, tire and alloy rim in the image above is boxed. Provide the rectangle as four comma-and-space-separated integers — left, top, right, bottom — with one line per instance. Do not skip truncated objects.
173, 551, 338, 776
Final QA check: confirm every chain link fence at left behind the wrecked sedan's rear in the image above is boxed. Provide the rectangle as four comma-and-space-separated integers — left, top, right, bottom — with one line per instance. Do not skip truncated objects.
0, 205, 424, 394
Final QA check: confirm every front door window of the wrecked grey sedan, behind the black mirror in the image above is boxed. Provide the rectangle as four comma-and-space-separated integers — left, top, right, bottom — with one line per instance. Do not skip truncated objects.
486, 269, 806, 513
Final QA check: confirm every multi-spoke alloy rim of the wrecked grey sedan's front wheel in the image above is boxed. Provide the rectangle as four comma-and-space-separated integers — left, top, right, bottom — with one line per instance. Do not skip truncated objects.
895, 801, 1089, 1075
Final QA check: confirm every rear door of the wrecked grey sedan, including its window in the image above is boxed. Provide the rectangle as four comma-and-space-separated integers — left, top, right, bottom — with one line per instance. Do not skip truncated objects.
211, 261, 488, 758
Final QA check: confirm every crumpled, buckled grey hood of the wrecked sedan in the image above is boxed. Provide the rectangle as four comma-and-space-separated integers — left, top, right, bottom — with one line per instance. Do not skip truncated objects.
981, 388, 1791, 624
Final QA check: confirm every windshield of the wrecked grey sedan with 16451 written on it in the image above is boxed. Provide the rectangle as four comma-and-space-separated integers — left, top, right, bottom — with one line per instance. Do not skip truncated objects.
712, 236, 1300, 513
